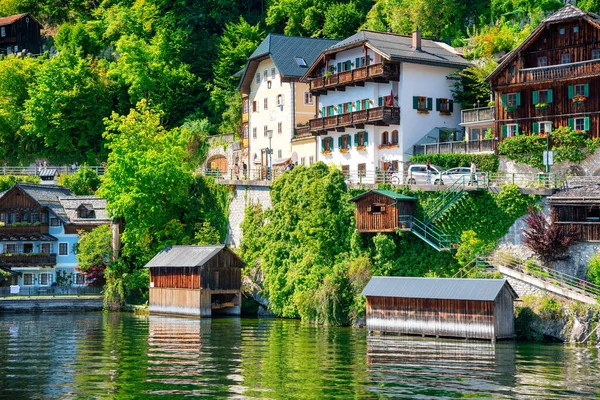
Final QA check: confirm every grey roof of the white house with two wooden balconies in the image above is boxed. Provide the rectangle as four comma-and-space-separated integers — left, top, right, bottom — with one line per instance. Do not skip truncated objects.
326, 31, 471, 67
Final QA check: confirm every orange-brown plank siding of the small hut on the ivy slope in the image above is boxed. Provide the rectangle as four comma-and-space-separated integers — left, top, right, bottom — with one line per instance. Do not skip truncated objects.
354, 193, 415, 232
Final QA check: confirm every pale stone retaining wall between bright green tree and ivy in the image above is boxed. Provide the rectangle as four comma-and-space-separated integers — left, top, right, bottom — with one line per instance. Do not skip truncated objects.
227, 181, 271, 247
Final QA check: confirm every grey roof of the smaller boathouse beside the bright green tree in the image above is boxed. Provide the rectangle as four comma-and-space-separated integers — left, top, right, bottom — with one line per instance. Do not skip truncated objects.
145, 244, 244, 268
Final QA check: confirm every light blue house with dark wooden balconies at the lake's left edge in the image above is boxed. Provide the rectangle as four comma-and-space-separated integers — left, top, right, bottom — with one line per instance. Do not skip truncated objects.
0, 183, 112, 288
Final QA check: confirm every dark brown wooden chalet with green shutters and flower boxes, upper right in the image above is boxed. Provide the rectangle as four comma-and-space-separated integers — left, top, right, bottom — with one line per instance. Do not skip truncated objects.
487, 5, 600, 140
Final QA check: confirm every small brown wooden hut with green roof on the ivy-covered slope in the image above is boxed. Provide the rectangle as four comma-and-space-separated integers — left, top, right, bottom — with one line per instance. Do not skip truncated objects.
350, 190, 417, 232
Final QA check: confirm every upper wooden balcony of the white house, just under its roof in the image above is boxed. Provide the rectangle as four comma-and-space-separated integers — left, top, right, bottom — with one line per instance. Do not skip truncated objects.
310, 63, 400, 95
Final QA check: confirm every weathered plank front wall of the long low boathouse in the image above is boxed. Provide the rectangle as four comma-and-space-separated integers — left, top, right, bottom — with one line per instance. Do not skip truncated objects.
366, 297, 495, 339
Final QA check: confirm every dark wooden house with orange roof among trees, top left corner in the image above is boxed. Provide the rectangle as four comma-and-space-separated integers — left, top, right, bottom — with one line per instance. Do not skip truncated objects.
0, 14, 42, 55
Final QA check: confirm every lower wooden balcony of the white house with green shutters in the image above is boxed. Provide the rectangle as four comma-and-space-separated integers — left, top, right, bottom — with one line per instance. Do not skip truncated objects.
310, 107, 400, 133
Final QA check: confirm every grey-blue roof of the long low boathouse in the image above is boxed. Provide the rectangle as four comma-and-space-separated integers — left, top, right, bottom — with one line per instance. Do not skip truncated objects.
362, 276, 517, 301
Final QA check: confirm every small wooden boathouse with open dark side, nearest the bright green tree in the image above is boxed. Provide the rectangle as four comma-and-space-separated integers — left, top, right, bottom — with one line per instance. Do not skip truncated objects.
146, 245, 244, 317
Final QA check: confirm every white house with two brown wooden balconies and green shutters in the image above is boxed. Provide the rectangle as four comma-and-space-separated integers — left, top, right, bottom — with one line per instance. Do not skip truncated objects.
302, 30, 469, 182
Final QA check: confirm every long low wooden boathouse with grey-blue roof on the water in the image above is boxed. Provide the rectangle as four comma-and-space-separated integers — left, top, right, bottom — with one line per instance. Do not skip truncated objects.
362, 276, 517, 340
